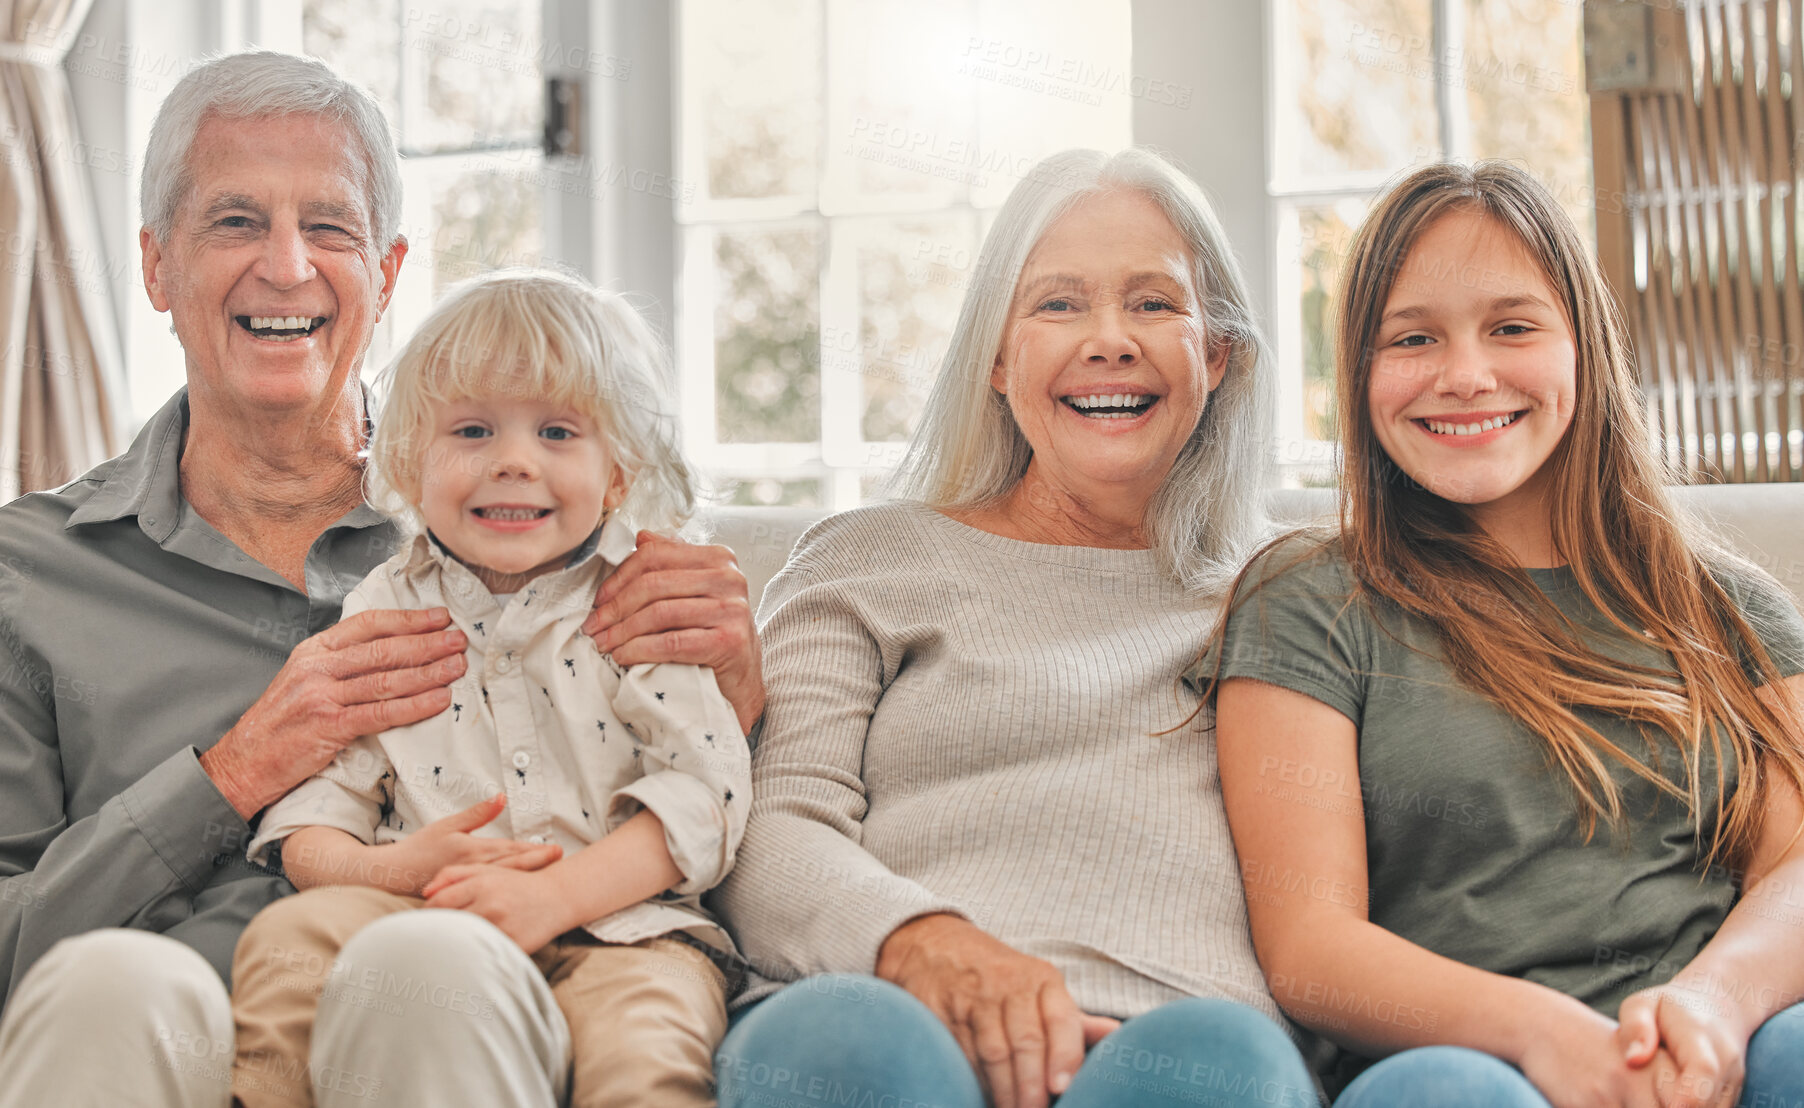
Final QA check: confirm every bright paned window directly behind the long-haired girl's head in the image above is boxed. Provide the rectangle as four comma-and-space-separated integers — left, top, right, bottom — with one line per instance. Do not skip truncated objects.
1268, 0, 1591, 482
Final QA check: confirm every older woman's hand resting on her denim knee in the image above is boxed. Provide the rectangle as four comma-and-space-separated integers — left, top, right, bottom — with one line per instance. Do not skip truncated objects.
877, 915, 1118, 1108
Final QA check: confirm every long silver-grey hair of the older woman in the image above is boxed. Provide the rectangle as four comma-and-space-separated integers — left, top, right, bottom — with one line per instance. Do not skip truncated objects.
889, 148, 1274, 594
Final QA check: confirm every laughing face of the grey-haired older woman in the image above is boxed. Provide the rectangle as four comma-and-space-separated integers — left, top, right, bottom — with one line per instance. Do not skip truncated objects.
990, 189, 1227, 509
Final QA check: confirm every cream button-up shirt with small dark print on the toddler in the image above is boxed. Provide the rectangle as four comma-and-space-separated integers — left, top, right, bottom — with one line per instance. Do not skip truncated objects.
249, 520, 750, 951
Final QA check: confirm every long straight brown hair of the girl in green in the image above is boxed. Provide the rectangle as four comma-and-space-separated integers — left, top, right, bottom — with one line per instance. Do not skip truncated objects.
1226, 162, 1804, 861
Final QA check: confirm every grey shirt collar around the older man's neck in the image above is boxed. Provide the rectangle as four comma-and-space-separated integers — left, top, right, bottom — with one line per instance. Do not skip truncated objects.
63, 384, 388, 543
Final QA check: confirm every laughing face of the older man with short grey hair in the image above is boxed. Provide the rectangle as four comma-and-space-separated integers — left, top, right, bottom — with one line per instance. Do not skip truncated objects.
141, 115, 408, 420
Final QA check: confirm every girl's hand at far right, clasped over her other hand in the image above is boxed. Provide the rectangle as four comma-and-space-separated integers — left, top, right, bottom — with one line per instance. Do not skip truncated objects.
1616, 983, 1748, 1108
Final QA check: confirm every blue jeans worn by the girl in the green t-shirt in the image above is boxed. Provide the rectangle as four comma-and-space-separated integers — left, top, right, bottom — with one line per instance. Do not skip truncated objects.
1335, 1003, 1804, 1108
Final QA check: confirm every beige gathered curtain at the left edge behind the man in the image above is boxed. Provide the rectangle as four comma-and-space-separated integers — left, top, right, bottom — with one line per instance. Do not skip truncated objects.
0, 0, 126, 503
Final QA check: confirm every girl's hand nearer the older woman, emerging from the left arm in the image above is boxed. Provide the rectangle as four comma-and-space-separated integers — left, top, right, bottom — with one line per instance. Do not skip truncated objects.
1515, 1000, 1678, 1108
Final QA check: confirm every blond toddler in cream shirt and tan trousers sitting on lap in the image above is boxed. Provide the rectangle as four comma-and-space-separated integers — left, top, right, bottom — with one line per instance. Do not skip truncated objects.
233, 272, 750, 1108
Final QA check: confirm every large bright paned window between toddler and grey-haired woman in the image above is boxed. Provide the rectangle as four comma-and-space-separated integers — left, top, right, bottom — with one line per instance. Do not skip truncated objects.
677, 0, 1133, 509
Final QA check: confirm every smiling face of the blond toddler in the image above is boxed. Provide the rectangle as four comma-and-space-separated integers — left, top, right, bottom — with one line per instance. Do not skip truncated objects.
420, 397, 626, 592
